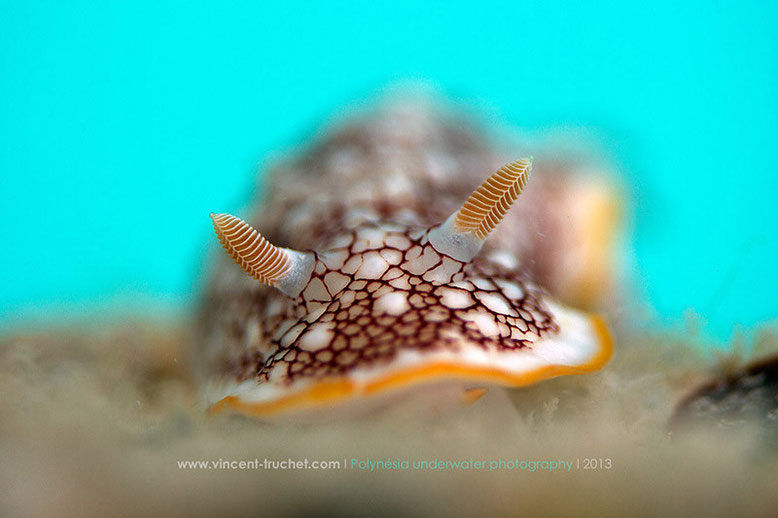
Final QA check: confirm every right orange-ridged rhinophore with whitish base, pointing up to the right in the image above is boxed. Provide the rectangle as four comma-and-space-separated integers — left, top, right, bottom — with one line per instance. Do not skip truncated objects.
430, 156, 534, 262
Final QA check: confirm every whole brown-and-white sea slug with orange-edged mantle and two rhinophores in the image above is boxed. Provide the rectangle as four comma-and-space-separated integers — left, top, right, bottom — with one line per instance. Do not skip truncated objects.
195, 103, 622, 416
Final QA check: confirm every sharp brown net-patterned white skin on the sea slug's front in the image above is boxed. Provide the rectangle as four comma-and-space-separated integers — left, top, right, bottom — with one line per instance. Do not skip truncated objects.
227, 224, 559, 383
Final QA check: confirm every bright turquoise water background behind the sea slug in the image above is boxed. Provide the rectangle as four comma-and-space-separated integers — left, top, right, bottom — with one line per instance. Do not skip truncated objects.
0, 1, 778, 340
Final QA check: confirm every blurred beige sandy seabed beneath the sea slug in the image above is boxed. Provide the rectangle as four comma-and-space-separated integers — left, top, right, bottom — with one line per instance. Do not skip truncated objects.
0, 322, 778, 516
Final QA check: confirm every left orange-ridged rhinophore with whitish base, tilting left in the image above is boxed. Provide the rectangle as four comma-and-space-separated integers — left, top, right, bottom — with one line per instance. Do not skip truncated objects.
211, 212, 313, 297
